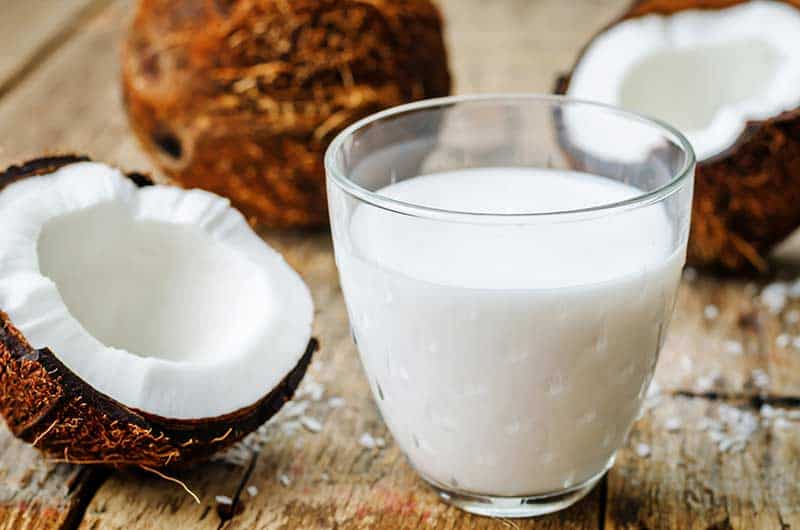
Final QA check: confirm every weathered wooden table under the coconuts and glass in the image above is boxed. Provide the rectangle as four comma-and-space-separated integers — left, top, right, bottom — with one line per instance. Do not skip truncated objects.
0, 0, 800, 530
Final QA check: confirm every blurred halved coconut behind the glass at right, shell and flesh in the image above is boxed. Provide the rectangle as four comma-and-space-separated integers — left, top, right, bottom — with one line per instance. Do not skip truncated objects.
557, 0, 800, 270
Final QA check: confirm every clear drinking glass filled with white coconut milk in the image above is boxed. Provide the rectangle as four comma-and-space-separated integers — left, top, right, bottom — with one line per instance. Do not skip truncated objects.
325, 95, 695, 517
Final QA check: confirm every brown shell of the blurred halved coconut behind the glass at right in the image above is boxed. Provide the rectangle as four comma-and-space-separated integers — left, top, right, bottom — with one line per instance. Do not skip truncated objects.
555, 0, 800, 273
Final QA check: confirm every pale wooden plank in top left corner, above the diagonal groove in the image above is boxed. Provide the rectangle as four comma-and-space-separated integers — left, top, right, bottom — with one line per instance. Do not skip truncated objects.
0, 0, 107, 94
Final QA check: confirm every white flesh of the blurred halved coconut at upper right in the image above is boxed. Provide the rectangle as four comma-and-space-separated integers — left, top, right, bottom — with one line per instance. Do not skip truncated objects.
567, 1, 800, 160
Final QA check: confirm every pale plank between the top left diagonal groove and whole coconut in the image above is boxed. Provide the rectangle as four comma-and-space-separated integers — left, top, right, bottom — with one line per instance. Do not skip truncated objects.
0, 0, 153, 171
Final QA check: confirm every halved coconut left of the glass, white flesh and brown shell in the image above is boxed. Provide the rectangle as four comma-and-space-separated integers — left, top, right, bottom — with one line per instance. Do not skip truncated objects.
0, 157, 316, 467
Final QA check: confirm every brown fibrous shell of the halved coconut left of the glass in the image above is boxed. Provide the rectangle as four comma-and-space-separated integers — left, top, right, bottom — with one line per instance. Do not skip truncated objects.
0, 156, 318, 468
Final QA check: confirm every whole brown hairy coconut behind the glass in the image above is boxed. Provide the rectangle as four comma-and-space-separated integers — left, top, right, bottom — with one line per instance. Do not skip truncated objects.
122, 0, 450, 227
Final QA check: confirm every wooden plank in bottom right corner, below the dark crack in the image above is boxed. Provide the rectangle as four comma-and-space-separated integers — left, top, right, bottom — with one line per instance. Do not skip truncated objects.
605, 397, 800, 530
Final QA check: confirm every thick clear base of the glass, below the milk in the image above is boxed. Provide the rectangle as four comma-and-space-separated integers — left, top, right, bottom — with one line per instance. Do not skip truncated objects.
422, 459, 613, 518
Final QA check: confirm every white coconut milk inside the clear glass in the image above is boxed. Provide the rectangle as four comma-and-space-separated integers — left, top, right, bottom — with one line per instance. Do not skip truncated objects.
337, 168, 685, 496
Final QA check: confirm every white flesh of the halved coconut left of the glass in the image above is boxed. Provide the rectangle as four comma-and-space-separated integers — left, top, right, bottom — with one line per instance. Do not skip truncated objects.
0, 163, 313, 419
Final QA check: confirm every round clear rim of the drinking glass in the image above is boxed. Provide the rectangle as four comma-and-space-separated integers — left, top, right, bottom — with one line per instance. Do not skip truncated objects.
324, 92, 696, 222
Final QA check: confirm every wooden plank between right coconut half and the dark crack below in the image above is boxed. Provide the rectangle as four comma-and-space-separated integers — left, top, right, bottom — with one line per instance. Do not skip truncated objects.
656, 274, 800, 400
